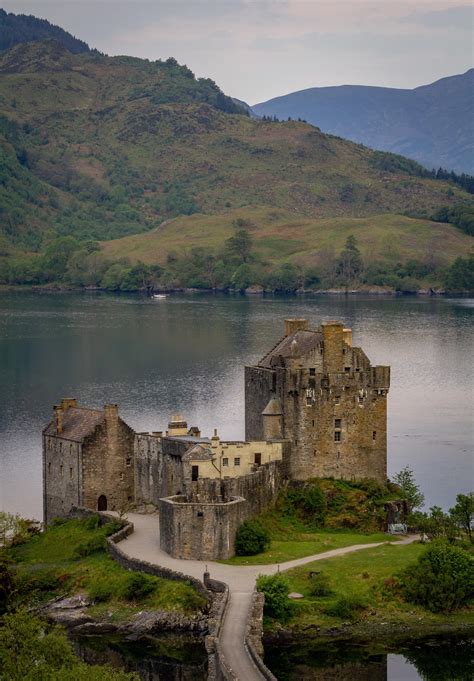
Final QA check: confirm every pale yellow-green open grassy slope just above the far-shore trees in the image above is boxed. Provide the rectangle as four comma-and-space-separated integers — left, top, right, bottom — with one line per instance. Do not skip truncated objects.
103, 207, 473, 265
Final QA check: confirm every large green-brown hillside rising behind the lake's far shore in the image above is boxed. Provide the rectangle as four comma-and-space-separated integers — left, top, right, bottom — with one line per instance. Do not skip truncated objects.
0, 41, 472, 285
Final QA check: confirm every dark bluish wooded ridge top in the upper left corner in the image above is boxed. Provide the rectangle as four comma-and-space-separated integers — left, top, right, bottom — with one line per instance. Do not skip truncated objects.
0, 9, 90, 54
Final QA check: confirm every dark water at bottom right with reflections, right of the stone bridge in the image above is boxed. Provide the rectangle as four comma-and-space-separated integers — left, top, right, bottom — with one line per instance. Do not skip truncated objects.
265, 638, 474, 681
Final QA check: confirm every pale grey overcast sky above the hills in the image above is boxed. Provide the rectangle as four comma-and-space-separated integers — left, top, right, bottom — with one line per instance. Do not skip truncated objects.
0, 0, 473, 104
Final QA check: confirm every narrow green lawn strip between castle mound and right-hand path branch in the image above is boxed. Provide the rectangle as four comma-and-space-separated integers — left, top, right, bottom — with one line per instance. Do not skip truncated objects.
221, 530, 390, 565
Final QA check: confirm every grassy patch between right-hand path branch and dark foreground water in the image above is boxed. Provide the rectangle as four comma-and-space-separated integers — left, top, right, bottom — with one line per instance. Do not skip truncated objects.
276, 543, 474, 630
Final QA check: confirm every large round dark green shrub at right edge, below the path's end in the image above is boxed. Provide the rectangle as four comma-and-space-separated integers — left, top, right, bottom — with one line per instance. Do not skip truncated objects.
400, 541, 474, 612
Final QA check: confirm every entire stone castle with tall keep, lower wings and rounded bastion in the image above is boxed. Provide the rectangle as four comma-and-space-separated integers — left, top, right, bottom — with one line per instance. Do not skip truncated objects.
43, 319, 390, 560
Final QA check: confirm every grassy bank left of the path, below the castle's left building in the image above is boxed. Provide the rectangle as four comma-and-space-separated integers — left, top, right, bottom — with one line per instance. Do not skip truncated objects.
8, 517, 205, 622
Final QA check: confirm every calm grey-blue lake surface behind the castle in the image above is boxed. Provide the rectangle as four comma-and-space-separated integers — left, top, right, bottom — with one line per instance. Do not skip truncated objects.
0, 293, 474, 517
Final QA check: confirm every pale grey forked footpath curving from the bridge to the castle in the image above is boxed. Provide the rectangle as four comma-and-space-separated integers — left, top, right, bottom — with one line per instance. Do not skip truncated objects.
116, 513, 418, 681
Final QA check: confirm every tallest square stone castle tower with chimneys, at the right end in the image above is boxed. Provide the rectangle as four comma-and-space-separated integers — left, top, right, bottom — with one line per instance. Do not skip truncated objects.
245, 319, 390, 482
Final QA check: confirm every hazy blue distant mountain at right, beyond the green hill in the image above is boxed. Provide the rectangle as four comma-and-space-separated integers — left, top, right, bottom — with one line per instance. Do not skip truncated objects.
252, 69, 474, 174
